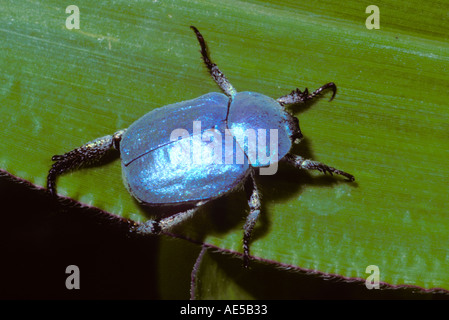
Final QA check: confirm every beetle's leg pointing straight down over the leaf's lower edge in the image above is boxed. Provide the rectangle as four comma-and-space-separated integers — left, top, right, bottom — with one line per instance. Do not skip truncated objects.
243, 172, 261, 268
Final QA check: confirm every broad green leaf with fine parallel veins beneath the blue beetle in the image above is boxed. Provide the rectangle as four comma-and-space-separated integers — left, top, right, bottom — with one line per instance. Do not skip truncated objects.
0, 0, 449, 296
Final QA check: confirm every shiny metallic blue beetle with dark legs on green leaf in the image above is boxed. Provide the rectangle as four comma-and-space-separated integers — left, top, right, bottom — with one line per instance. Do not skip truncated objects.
47, 26, 354, 266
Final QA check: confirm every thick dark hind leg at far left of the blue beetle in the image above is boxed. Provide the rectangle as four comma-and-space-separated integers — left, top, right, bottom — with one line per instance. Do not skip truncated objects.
47, 130, 126, 196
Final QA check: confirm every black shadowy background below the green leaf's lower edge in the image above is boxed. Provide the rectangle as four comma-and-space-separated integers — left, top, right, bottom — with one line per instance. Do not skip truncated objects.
0, 171, 449, 299
